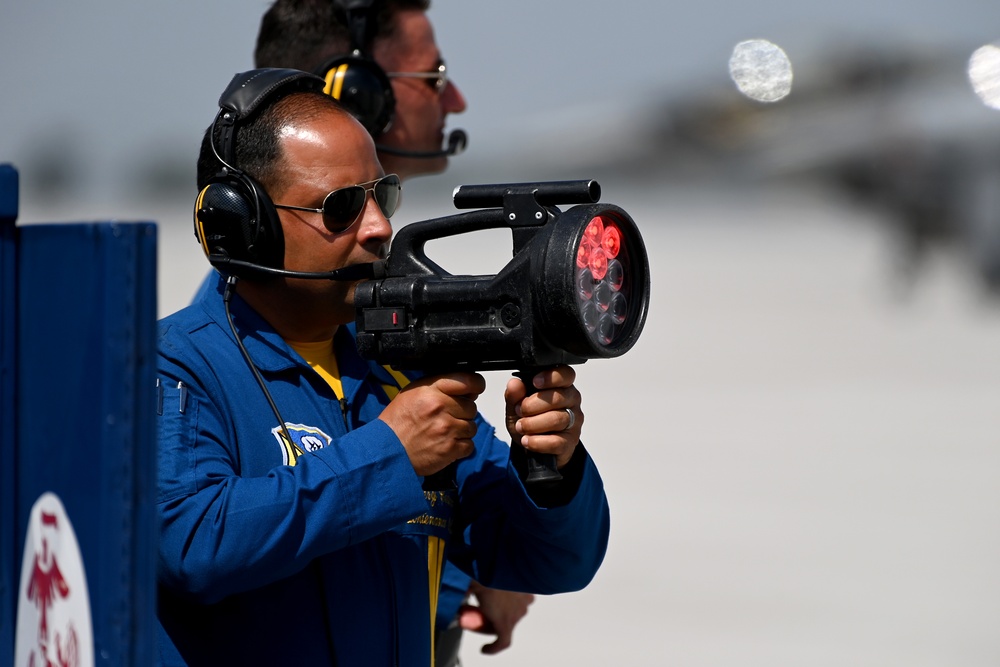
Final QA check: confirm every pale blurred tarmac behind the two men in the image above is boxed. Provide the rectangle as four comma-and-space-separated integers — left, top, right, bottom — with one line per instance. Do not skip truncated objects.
22, 179, 1000, 667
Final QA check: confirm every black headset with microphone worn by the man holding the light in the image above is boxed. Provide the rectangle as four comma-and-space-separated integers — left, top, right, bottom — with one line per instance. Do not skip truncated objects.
194, 68, 375, 280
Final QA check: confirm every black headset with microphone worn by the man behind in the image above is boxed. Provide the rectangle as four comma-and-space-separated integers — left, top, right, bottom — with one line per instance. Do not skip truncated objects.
314, 0, 468, 158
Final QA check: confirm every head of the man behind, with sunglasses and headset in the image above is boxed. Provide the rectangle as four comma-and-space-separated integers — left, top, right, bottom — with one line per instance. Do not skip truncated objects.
254, 0, 465, 181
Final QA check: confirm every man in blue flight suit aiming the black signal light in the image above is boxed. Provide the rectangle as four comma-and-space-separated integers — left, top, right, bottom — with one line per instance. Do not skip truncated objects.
157, 69, 609, 667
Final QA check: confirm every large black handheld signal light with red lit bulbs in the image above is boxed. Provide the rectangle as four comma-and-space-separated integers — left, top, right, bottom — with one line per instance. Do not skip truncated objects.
355, 181, 649, 483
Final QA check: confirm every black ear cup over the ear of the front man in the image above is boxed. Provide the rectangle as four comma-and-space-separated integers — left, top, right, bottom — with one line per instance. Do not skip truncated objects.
194, 174, 285, 277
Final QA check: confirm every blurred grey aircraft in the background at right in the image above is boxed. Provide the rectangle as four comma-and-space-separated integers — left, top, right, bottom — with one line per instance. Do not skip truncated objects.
592, 42, 1000, 299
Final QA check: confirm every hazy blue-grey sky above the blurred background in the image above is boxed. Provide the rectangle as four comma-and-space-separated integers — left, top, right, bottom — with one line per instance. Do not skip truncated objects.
0, 0, 1000, 209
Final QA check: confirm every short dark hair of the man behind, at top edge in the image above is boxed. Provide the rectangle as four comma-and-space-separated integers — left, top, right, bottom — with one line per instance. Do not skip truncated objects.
254, 0, 431, 72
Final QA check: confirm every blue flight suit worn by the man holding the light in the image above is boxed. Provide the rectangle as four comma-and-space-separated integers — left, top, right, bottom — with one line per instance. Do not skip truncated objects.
157, 281, 610, 667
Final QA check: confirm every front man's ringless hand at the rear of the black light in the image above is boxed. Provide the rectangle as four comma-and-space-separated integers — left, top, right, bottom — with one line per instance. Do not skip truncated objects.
379, 373, 486, 476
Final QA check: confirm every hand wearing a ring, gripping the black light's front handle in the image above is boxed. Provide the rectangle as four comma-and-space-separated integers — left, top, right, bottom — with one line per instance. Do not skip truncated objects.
504, 366, 583, 468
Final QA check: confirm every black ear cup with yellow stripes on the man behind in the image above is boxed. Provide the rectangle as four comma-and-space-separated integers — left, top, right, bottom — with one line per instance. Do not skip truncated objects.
316, 56, 396, 138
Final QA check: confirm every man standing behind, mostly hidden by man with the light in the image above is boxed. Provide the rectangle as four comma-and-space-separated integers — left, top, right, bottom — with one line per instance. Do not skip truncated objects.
254, 0, 534, 667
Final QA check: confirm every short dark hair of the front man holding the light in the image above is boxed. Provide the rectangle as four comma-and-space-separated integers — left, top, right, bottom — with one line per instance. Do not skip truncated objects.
197, 91, 353, 192
